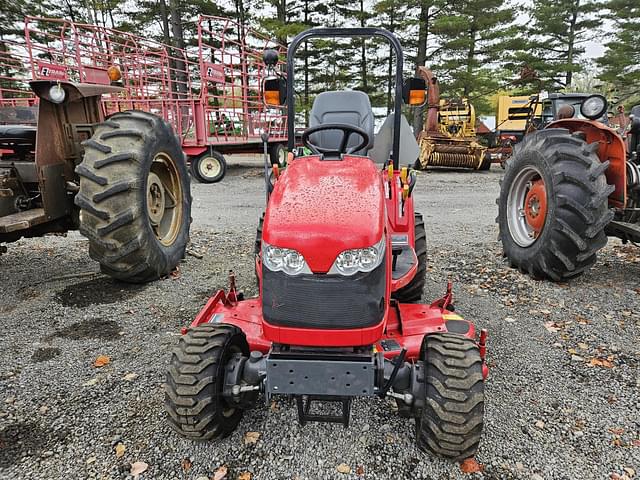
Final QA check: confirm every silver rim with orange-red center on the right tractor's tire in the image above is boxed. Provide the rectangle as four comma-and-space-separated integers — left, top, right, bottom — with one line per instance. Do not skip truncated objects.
507, 166, 547, 247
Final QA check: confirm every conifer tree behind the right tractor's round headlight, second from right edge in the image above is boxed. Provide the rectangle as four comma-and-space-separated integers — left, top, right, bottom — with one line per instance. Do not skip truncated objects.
522, 0, 604, 89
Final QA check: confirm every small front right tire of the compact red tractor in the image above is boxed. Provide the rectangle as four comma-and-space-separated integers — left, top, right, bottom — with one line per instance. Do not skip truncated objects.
416, 333, 484, 461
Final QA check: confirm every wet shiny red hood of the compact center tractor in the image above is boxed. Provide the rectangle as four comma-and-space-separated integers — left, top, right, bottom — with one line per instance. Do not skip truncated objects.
263, 155, 385, 273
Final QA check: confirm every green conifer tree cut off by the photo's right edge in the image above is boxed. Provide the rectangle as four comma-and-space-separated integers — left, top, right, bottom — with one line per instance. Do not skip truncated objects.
597, 0, 640, 103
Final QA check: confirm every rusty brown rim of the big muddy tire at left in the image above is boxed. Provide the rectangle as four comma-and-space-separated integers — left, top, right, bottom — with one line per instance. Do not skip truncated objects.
147, 152, 183, 246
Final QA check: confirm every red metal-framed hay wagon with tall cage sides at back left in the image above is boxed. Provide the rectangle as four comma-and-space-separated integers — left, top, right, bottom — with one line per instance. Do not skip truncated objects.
0, 16, 287, 183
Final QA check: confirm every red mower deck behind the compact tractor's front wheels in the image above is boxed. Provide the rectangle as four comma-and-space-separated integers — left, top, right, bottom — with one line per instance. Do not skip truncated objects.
191, 284, 476, 360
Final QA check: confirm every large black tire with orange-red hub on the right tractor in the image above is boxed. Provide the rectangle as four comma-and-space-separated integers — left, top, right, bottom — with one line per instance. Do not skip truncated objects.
497, 128, 614, 281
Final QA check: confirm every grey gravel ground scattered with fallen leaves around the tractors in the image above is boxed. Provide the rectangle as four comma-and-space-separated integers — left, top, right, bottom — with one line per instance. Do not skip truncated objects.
0, 168, 640, 480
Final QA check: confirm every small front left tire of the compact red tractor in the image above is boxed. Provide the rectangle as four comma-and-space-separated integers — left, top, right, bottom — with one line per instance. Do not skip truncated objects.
165, 323, 249, 440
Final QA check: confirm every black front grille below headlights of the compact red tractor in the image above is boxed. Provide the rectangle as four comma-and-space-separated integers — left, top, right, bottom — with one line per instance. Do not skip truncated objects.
262, 260, 385, 329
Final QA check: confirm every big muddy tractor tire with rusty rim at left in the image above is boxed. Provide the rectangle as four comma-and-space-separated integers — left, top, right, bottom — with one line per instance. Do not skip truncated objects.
75, 111, 191, 283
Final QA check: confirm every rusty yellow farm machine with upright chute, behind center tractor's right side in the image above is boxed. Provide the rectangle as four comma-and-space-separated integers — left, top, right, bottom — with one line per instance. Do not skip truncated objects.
415, 67, 491, 170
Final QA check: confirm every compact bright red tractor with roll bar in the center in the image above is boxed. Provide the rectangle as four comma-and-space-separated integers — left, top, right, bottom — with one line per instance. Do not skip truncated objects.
166, 28, 488, 460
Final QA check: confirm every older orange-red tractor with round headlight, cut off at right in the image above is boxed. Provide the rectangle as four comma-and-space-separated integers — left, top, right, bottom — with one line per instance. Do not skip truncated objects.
497, 95, 640, 281
